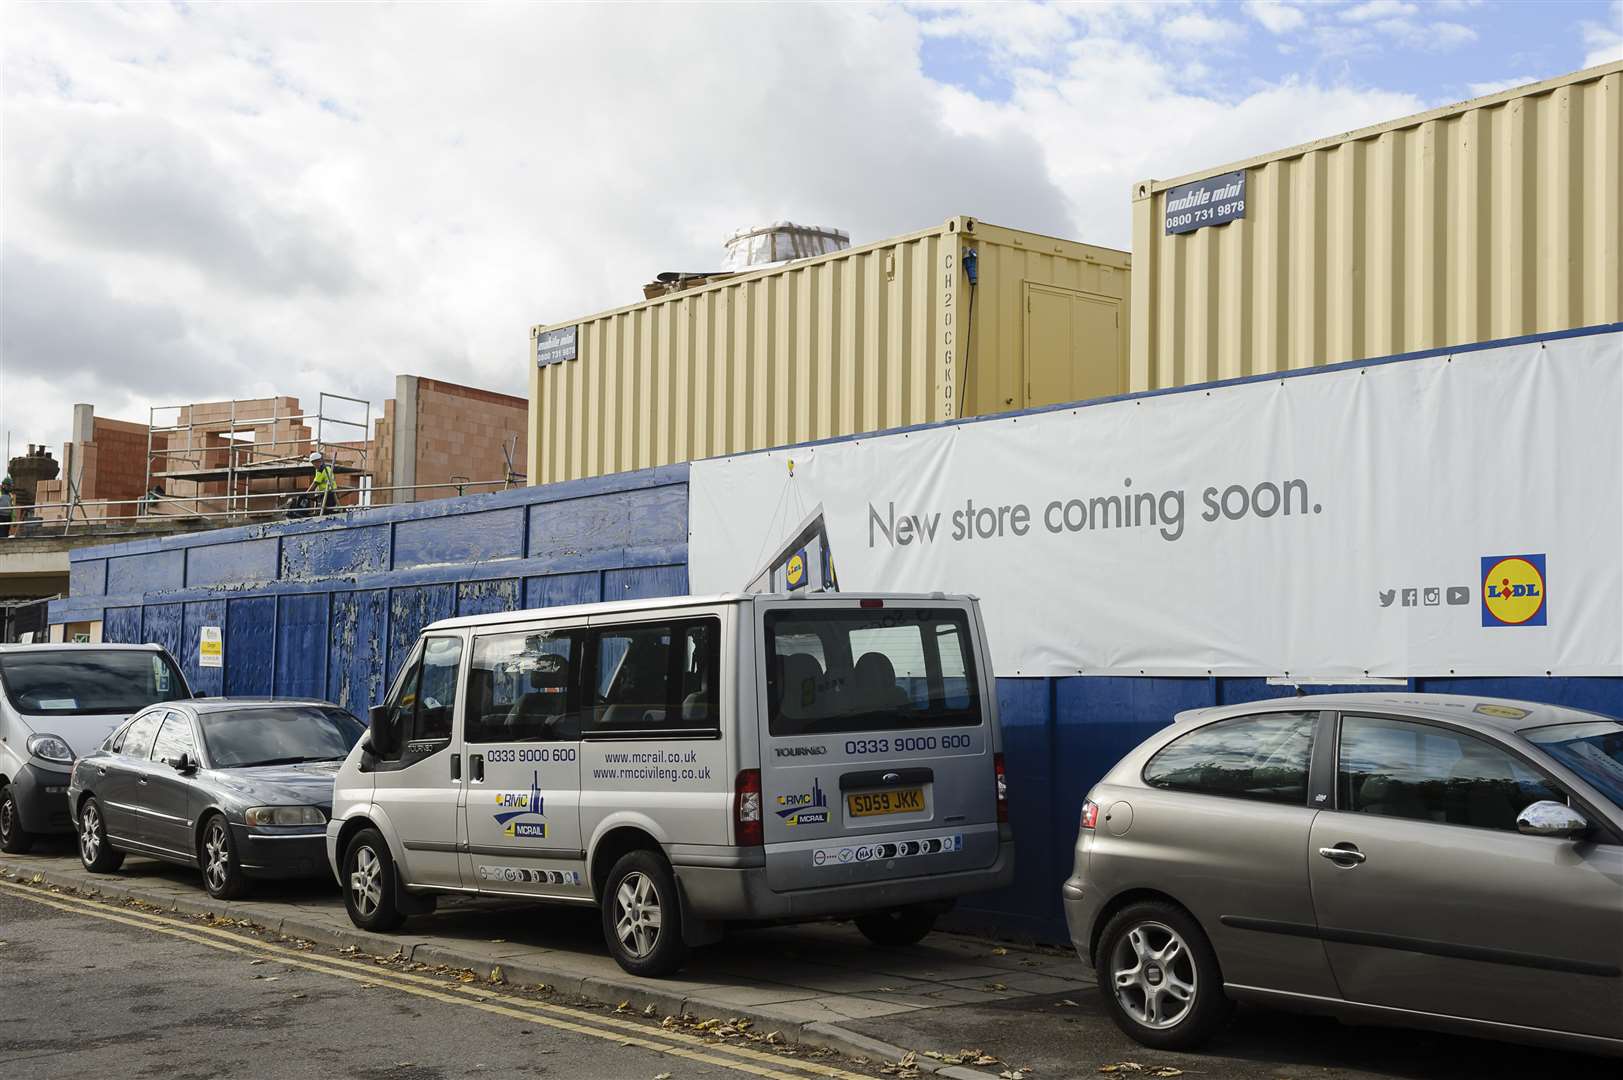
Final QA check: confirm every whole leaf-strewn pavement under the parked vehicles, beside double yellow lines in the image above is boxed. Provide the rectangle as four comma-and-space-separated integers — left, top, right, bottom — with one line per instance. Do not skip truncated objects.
9, 843, 1615, 1080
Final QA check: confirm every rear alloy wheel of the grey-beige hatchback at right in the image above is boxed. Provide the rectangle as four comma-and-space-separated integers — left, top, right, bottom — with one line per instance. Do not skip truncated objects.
1097, 901, 1230, 1051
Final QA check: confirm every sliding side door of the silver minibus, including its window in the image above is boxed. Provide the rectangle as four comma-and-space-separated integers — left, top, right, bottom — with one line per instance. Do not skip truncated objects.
463, 627, 591, 900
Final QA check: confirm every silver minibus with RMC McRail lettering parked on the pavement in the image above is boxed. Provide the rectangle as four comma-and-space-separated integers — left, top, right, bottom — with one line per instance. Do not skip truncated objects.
328, 593, 1014, 974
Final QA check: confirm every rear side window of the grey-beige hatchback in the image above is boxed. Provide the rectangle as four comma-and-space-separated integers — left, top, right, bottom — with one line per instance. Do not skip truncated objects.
1144, 713, 1318, 806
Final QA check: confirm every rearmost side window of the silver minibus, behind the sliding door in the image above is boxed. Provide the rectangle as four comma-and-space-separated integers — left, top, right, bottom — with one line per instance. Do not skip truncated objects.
588, 619, 721, 737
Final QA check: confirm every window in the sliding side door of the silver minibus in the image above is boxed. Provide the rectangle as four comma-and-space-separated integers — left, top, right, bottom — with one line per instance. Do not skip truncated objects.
466, 630, 584, 742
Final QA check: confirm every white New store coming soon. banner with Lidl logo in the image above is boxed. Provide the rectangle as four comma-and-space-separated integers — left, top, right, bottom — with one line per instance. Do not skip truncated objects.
688, 333, 1623, 682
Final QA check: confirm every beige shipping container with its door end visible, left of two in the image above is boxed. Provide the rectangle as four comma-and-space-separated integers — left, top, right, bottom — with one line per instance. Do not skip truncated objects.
529, 218, 1130, 484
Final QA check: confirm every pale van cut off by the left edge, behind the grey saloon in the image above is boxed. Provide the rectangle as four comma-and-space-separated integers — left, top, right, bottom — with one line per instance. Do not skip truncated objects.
0, 645, 192, 854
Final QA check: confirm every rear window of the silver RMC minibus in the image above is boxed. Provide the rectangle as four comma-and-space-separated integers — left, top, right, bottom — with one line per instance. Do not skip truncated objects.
766, 607, 980, 736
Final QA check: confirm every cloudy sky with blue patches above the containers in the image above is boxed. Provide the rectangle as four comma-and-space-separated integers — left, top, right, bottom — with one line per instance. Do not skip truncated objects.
0, 0, 1623, 456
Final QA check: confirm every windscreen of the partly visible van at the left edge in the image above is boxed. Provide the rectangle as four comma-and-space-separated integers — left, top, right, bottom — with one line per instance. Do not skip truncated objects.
0, 648, 188, 716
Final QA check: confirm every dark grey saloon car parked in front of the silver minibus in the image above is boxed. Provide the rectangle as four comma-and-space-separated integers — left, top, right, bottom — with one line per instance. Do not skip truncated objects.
68, 698, 365, 898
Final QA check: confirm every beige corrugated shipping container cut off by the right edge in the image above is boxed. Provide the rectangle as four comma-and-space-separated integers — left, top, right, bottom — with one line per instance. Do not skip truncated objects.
1131, 63, 1623, 390
